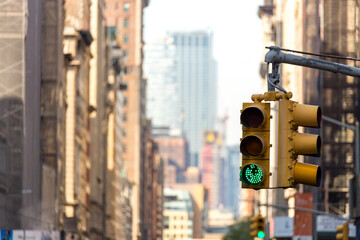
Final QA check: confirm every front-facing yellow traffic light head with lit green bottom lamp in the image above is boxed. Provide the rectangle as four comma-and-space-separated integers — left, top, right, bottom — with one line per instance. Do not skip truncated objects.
240, 102, 270, 189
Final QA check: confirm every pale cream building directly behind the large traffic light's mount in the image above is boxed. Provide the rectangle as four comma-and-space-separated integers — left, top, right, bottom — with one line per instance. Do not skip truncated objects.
255, 0, 304, 217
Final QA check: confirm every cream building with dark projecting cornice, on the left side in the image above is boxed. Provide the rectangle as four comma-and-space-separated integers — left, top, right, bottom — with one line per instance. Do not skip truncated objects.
63, 0, 93, 236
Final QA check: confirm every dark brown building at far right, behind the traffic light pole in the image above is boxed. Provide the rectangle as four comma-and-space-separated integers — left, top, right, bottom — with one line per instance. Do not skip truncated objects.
316, 0, 360, 214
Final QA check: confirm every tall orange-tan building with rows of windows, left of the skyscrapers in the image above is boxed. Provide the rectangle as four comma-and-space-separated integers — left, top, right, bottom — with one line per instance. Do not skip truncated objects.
105, 0, 149, 240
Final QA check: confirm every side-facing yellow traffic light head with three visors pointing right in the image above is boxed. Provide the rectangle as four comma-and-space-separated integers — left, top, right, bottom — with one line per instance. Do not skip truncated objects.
277, 99, 321, 188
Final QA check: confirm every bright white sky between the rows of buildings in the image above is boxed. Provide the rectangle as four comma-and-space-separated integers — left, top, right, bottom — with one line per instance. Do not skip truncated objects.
144, 0, 263, 145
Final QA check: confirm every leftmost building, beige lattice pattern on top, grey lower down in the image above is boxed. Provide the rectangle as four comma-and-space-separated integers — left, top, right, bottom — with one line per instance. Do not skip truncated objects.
0, 1, 38, 228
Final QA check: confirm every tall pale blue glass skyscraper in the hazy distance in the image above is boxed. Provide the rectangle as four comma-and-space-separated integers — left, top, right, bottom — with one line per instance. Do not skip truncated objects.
172, 31, 217, 166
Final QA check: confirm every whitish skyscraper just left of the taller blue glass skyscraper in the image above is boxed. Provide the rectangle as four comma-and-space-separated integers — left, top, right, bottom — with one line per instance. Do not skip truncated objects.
144, 37, 181, 136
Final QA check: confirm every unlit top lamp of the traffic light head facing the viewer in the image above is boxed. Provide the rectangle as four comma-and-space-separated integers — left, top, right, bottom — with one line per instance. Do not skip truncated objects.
240, 106, 266, 128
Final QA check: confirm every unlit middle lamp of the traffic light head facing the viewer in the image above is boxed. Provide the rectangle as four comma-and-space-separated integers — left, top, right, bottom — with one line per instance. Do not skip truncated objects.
240, 135, 267, 157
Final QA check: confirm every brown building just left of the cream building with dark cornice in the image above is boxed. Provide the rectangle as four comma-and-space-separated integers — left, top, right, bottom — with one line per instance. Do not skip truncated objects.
39, 1, 67, 229
